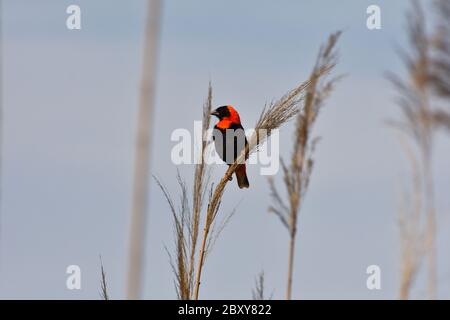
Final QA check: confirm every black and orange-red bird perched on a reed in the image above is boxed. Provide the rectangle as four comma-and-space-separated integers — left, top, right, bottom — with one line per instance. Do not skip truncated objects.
211, 105, 250, 189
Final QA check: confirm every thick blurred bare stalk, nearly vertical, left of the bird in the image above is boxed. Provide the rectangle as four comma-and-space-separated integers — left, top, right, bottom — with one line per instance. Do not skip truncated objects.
127, 0, 161, 299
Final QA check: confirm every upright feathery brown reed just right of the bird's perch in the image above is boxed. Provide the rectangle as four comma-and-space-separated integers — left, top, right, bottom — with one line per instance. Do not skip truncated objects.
269, 32, 341, 300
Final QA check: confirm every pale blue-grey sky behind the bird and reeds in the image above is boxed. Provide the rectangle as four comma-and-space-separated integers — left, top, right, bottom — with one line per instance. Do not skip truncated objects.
0, 0, 450, 299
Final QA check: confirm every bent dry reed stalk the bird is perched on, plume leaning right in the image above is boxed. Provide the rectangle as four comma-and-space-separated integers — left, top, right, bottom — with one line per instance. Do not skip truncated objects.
194, 66, 331, 300
